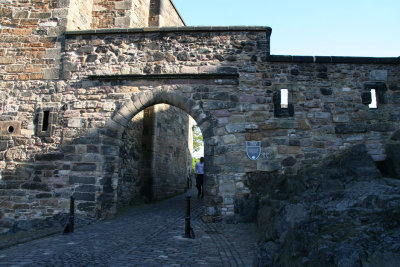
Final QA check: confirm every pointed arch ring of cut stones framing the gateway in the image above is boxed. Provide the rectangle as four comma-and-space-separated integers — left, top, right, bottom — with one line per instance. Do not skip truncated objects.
97, 89, 220, 220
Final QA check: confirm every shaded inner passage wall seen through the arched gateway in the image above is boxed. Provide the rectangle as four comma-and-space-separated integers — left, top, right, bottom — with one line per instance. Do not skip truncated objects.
118, 104, 192, 207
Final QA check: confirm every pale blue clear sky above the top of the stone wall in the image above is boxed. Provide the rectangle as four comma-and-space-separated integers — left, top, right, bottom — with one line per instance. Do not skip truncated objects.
173, 0, 400, 57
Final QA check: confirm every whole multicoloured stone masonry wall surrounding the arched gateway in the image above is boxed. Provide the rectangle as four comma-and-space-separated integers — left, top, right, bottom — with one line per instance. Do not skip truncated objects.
0, 1, 400, 232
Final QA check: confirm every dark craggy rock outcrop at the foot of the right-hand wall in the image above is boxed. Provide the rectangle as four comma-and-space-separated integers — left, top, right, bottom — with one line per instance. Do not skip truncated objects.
252, 145, 400, 266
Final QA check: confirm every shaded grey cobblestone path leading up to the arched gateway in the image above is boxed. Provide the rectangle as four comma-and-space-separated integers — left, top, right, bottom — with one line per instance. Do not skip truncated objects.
0, 192, 258, 267
